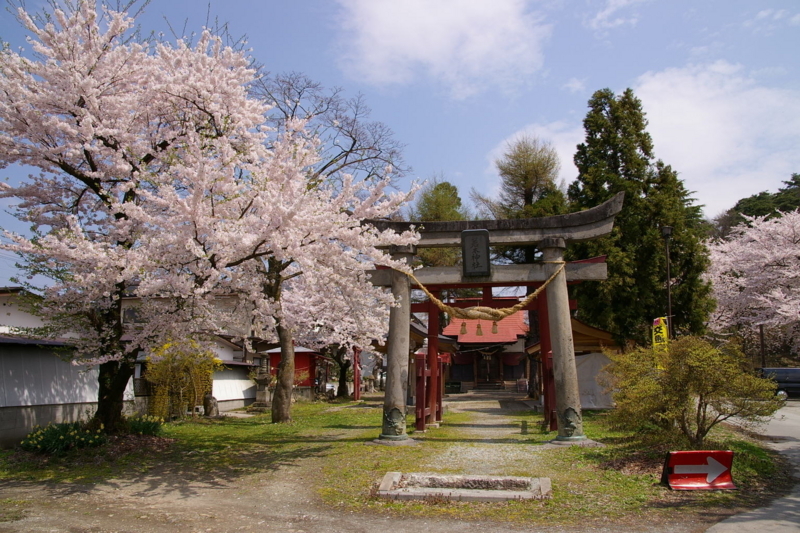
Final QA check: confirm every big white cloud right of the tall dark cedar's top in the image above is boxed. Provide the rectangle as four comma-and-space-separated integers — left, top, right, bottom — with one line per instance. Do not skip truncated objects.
634, 61, 800, 216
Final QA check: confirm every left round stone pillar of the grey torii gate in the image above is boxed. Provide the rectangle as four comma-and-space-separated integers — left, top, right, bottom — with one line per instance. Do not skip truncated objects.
379, 246, 417, 441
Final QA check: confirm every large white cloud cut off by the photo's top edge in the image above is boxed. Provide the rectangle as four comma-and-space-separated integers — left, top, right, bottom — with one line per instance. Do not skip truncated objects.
338, 0, 551, 99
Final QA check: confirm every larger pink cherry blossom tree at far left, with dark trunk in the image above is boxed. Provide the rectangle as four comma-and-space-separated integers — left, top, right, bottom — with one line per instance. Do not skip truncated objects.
0, 1, 272, 430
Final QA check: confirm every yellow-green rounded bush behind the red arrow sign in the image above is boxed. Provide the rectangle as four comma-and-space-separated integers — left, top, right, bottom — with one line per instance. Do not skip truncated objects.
606, 336, 783, 447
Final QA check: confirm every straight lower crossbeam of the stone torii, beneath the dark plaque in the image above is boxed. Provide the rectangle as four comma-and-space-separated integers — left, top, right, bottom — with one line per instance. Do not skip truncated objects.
369, 263, 608, 287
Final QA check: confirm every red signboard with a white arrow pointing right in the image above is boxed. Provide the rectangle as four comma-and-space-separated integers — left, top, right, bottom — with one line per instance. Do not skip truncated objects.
661, 450, 736, 490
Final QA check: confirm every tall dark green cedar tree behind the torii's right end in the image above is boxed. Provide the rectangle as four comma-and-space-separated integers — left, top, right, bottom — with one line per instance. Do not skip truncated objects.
568, 89, 714, 343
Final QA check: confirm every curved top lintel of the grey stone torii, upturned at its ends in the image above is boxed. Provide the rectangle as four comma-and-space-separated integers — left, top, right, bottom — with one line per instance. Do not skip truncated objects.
365, 192, 625, 248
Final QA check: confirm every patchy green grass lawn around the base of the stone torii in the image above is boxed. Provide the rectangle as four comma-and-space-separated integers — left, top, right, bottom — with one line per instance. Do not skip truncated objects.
0, 400, 792, 524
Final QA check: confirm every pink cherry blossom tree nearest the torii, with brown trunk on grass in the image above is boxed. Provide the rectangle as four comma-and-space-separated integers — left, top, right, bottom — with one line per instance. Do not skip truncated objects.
140, 121, 417, 422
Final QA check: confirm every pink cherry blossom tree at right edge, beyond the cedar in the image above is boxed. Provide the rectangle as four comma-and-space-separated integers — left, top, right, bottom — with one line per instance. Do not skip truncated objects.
708, 211, 800, 351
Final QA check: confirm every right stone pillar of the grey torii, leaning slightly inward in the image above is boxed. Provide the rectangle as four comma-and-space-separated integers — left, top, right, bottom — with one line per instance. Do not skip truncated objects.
539, 237, 586, 443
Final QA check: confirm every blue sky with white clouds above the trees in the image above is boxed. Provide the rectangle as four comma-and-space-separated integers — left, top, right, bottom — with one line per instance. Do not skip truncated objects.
0, 0, 800, 285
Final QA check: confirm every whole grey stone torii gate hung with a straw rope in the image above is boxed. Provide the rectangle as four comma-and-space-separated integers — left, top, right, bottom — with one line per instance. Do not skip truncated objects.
367, 193, 624, 443
